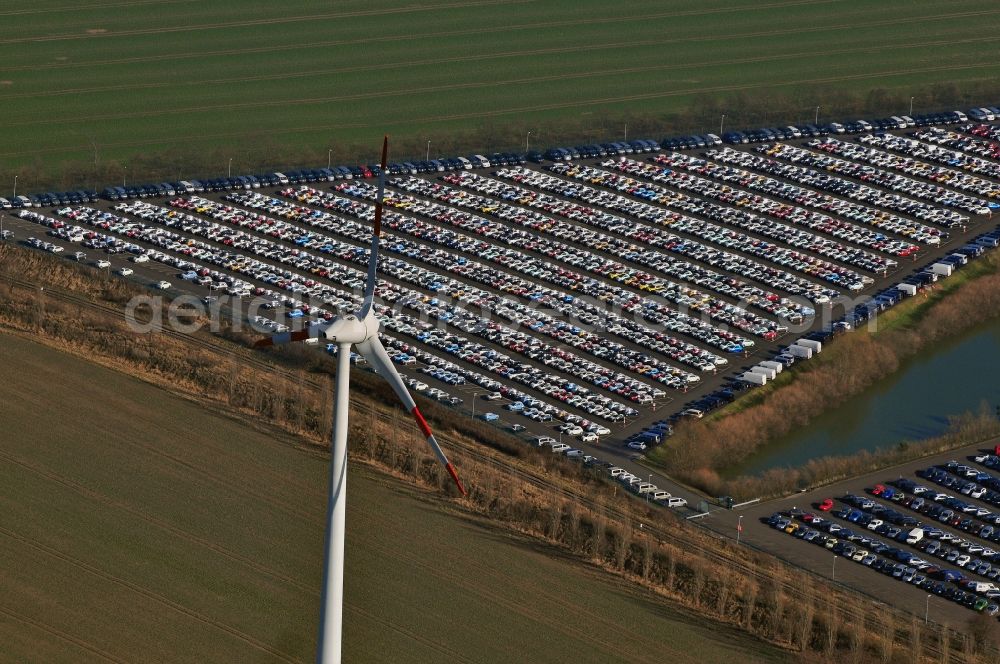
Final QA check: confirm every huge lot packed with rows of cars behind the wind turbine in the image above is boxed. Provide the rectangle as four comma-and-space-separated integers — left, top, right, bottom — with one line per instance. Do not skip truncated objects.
5, 111, 997, 491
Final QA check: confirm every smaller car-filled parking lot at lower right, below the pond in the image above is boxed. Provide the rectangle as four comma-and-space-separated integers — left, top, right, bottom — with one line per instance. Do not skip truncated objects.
700, 439, 1000, 626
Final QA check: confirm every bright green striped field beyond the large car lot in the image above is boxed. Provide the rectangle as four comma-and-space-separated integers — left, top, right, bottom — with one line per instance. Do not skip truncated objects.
0, 0, 1000, 184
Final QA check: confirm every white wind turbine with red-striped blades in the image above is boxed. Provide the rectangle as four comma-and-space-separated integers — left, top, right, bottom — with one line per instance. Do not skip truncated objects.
255, 136, 466, 664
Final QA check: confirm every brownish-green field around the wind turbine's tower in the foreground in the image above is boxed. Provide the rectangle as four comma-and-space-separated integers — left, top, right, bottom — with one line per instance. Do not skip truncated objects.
0, 336, 787, 664
